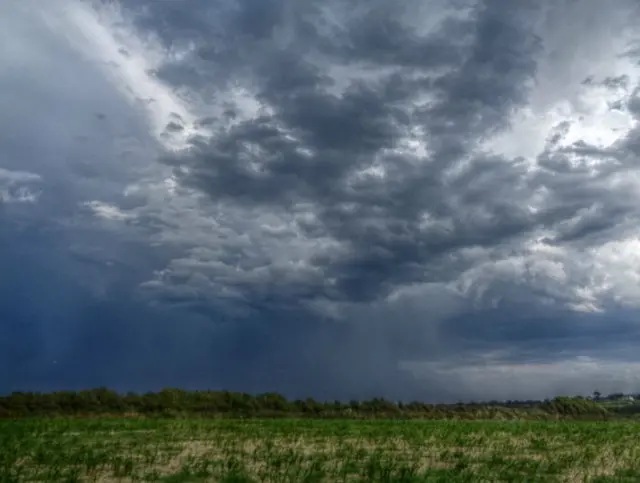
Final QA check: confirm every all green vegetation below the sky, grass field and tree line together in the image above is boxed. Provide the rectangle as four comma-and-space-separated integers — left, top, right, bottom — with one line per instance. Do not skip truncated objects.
0, 389, 640, 483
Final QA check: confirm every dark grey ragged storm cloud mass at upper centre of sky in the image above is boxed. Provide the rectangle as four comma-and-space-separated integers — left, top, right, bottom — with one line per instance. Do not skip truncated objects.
152, 1, 540, 301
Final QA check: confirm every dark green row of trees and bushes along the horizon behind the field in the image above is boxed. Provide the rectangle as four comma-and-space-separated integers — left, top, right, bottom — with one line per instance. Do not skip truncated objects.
0, 388, 638, 419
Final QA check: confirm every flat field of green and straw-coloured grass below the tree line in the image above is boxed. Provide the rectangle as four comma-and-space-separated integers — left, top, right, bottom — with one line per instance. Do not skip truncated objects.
0, 419, 640, 483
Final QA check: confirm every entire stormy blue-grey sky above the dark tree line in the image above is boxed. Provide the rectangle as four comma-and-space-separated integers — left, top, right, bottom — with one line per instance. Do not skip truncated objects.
0, 0, 640, 402
